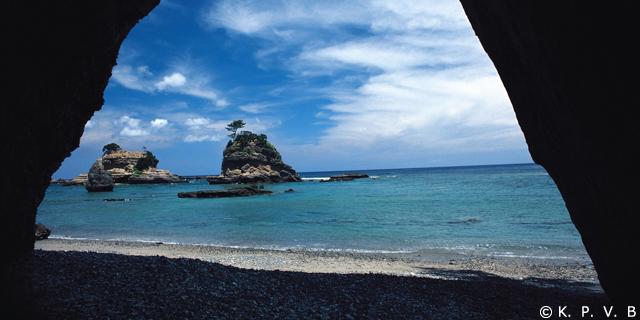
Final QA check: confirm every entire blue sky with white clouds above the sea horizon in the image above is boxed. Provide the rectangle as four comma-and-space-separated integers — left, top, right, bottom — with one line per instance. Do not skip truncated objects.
53, 0, 532, 178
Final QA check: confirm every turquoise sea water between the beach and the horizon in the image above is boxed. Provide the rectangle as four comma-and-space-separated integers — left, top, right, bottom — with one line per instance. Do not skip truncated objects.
37, 164, 587, 259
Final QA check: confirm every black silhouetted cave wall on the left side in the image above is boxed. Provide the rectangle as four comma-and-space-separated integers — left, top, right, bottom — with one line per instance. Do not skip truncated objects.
0, 0, 160, 265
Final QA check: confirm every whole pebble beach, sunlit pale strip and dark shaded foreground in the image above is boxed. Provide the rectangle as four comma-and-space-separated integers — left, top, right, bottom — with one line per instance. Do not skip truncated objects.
2, 239, 610, 319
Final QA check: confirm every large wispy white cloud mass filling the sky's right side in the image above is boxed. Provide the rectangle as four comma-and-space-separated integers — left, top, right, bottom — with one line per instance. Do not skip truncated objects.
204, 0, 526, 160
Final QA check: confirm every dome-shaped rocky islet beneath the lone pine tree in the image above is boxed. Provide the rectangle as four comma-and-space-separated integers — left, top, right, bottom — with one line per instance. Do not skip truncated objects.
207, 131, 302, 184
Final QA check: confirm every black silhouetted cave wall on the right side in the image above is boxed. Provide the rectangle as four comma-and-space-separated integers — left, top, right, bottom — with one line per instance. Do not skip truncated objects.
461, 0, 640, 305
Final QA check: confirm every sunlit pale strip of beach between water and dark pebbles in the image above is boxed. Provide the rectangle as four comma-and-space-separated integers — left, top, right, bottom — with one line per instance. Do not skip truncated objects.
35, 239, 602, 291
